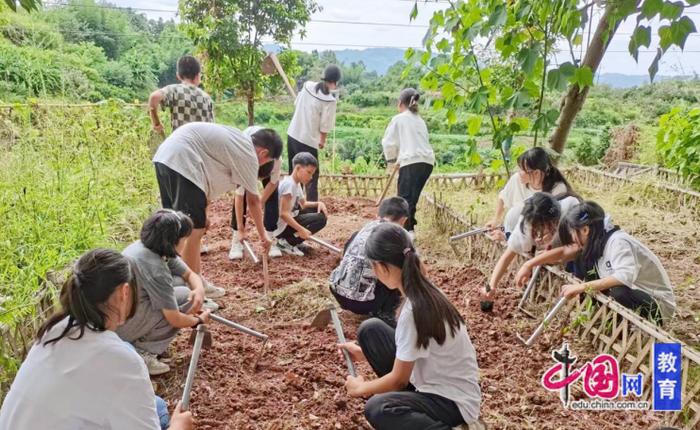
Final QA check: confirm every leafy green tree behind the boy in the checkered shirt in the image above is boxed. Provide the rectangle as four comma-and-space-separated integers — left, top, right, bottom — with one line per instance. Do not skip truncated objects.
180, 0, 318, 124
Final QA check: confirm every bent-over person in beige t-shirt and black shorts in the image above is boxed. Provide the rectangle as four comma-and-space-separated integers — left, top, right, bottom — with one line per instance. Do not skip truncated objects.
153, 122, 282, 298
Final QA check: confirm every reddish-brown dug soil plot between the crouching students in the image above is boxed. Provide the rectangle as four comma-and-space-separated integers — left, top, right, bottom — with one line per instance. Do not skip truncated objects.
156, 198, 656, 429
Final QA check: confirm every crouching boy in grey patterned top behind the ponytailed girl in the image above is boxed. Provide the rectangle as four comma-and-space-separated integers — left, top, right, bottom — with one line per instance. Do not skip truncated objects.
330, 197, 410, 327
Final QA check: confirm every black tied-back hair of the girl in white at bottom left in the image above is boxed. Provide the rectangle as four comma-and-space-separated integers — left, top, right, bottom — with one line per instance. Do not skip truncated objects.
37, 249, 137, 346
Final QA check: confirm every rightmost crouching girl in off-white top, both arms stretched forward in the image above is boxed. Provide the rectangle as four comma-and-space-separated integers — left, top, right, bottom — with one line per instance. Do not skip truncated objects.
516, 201, 676, 324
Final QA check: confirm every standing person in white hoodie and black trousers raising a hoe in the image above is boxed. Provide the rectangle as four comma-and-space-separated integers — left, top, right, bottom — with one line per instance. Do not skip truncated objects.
287, 64, 341, 201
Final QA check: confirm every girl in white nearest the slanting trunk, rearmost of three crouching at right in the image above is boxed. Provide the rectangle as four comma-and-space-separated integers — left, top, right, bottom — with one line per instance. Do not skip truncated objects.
486, 147, 574, 242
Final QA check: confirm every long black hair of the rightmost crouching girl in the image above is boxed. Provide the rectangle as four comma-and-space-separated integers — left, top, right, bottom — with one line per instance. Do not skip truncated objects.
559, 201, 609, 268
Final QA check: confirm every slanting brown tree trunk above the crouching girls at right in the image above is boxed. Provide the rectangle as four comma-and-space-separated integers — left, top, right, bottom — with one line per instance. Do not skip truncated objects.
549, 5, 620, 153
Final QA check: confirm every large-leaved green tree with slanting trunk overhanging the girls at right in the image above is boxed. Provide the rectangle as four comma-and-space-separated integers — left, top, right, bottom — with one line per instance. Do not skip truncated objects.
407, 0, 700, 159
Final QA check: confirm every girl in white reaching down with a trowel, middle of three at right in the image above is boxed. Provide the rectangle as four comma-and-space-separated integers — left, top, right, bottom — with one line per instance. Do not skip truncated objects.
481, 192, 580, 299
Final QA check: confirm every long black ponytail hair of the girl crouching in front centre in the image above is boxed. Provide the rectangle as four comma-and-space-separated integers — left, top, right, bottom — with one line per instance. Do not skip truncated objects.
365, 223, 464, 348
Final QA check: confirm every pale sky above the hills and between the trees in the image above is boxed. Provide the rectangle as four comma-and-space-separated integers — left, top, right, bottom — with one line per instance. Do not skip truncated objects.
115, 0, 700, 75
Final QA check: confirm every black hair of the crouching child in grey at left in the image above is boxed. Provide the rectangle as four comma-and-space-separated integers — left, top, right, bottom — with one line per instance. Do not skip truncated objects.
141, 209, 194, 258
